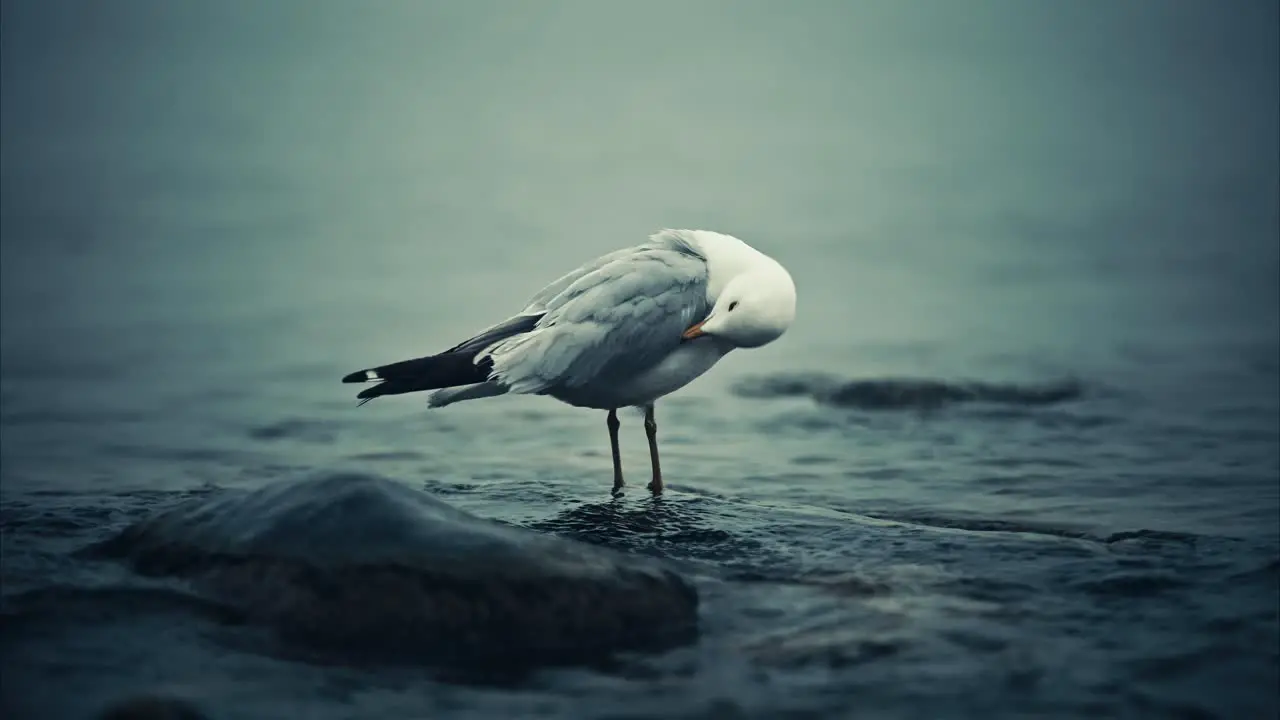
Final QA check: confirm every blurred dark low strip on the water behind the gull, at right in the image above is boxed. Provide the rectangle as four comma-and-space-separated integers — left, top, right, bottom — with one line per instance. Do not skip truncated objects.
732, 373, 1084, 410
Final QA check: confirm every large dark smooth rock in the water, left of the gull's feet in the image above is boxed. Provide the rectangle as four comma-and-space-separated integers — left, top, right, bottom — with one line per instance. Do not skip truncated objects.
95, 474, 698, 666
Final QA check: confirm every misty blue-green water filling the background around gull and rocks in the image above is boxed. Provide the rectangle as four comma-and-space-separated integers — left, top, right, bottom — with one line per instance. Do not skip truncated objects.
0, 3, 1280, 719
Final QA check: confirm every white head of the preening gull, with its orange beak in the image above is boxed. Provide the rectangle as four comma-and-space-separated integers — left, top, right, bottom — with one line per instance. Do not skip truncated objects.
684, 255, 796, 347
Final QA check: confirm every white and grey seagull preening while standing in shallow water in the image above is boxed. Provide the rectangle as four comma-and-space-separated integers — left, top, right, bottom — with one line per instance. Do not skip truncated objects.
342, 229, 796, 497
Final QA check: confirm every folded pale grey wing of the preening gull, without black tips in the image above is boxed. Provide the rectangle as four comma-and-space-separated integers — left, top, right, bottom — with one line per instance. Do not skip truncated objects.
477, 243, 709, 392
